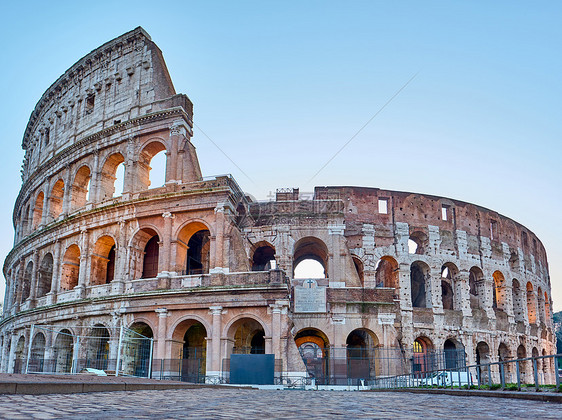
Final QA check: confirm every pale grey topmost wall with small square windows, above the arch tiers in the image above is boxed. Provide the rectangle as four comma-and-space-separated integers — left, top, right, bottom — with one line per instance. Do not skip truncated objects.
22, 27, 182, 182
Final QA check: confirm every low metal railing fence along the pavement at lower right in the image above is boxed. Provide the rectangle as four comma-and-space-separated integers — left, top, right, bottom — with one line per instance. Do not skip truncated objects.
369, 354, 562, 391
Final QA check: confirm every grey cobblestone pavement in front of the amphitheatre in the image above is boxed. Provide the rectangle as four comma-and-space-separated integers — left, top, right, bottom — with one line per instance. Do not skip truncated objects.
0, 389, 562, 419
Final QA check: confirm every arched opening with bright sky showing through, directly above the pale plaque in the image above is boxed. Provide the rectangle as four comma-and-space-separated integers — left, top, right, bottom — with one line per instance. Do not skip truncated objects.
293, 236, 328, 279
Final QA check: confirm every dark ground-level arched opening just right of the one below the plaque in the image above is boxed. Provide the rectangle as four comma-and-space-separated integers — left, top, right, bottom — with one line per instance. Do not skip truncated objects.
346, 328, 379, 380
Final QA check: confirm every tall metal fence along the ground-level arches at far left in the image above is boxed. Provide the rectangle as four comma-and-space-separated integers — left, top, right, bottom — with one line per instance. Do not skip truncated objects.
14, 325, 153, 377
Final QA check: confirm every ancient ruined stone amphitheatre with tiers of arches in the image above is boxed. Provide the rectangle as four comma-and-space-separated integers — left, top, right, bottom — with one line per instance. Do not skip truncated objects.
0, 27, 555, 384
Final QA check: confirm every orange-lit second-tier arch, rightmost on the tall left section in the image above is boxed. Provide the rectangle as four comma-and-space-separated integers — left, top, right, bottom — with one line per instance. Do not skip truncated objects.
176, 221, 211, 275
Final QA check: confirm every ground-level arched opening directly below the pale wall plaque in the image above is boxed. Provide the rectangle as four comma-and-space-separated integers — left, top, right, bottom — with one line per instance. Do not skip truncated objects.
295, 328, 330, 385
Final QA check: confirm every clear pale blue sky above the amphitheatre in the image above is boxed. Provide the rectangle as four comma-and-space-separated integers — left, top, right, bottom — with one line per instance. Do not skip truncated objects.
0, 0, 562, 311
